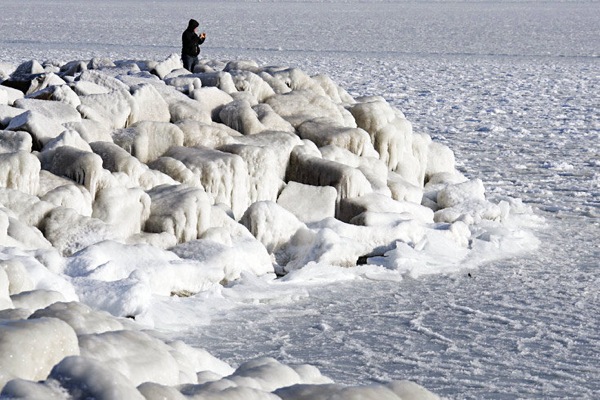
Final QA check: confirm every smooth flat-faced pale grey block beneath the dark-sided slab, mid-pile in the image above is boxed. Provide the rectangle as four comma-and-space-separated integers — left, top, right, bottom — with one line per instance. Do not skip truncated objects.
277, 181, 337, 223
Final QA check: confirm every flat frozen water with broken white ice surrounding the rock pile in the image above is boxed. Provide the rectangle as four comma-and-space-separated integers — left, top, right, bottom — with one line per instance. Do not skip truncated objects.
0, 0, 600, 399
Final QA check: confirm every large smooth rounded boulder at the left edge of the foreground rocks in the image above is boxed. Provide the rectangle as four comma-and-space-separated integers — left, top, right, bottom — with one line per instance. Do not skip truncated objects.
0, 318, 79, 387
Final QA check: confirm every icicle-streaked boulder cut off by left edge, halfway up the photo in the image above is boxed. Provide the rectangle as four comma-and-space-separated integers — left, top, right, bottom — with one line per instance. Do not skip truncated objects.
0, 151, 41, 194
